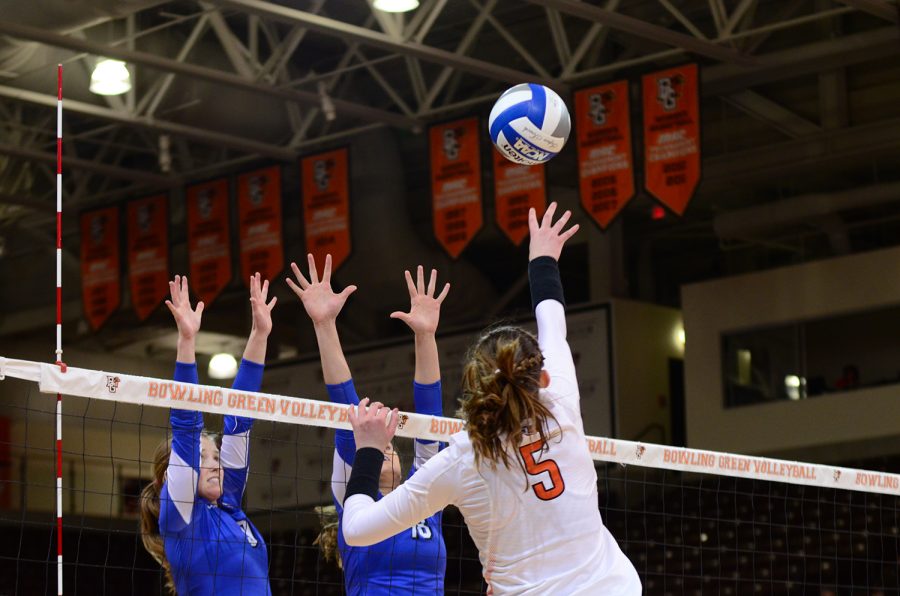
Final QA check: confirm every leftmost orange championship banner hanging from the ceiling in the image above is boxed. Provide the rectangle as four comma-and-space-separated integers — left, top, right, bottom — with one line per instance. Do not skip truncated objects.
81, 207, 121, 331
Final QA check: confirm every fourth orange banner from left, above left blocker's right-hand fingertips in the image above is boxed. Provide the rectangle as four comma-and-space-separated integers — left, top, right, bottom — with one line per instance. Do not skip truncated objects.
238, 166, 284, 287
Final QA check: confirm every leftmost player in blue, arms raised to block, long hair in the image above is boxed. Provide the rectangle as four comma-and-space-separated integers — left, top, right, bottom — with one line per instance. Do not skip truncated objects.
141, 273, 276, 596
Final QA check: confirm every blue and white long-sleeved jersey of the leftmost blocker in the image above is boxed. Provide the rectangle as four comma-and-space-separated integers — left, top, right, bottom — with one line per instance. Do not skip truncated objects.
159, 360, 272, 596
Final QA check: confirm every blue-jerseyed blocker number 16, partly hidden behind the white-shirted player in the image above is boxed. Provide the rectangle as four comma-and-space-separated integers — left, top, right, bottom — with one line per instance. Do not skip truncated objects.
288, 255, 450, 596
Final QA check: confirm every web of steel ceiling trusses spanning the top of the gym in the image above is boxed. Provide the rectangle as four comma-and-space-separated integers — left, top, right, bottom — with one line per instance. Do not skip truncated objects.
0, 0, 900, 217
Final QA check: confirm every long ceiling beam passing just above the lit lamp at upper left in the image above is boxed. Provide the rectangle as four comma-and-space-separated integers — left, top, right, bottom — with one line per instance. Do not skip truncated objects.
0, 21, 419, 129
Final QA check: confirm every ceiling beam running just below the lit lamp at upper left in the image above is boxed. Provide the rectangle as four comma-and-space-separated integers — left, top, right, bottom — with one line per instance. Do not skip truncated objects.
0, 85, 297, 161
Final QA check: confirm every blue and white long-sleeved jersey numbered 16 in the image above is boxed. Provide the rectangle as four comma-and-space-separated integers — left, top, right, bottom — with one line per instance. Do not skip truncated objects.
327, 379, 447, 596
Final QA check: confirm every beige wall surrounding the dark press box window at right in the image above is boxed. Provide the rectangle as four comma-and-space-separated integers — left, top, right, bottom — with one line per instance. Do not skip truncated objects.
682, 248, 900, 459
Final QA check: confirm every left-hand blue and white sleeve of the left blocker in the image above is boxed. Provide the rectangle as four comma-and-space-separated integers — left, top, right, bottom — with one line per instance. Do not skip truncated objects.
159, 362, 203, 536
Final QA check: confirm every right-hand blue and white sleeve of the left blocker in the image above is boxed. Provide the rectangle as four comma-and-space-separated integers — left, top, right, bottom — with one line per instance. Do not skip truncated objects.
219, 359, 265, 511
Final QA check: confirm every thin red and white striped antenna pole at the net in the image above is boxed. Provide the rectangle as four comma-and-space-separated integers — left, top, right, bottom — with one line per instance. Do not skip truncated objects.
56, 64, 66, 594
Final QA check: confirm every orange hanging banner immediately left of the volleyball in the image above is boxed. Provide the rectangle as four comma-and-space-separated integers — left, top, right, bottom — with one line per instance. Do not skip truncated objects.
428, 118, 482, 259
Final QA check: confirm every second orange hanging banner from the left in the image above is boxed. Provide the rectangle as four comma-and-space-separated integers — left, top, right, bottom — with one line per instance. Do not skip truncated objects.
127, 195, 169, 321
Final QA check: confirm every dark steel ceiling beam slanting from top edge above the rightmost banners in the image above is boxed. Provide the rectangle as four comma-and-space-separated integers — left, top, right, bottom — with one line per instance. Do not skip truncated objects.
528, 0, 756, 66
